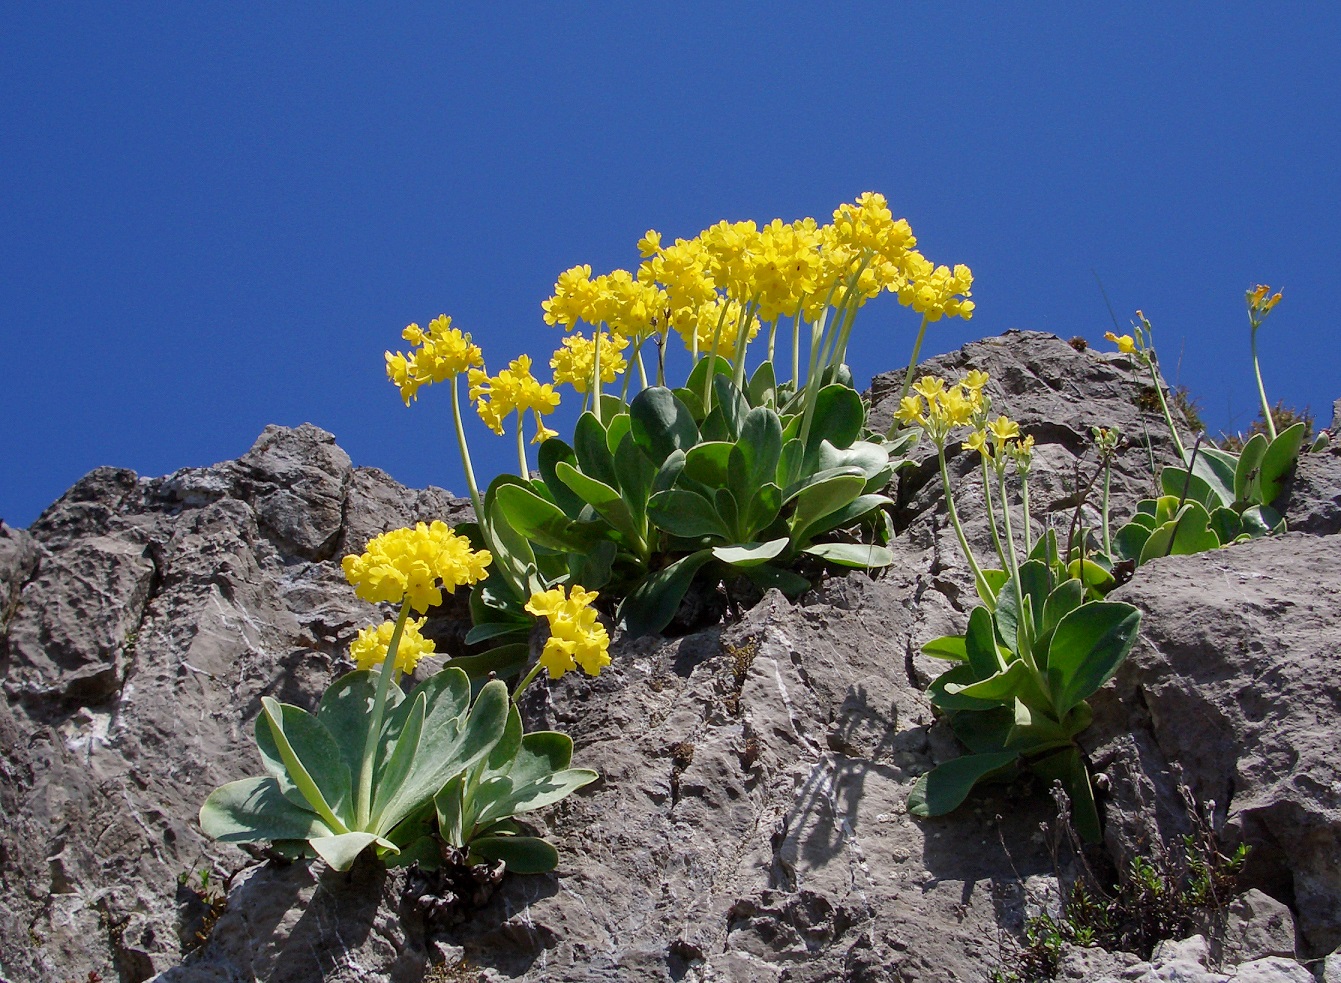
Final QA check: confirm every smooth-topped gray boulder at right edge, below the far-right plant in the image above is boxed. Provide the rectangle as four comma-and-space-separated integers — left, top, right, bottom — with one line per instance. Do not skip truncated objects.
1082, 532, 1341, 953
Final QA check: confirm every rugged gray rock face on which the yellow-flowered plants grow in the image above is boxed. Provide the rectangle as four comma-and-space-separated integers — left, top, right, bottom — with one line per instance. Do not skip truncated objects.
0, 333, 1341, 983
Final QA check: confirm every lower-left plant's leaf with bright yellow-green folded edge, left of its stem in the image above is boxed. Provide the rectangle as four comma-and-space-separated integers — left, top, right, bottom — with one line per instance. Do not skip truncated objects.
256, 696, 353, 833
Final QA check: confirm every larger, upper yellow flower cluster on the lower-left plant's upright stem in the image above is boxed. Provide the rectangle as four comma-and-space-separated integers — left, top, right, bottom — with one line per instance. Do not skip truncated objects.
343, 520, 492, 612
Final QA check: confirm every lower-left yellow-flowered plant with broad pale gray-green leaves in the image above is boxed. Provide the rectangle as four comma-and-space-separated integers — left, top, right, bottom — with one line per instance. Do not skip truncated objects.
200, 522, 595, 872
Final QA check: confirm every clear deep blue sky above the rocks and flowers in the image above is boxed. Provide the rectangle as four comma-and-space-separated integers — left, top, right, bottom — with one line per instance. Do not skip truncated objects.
0, 3, 1341, 526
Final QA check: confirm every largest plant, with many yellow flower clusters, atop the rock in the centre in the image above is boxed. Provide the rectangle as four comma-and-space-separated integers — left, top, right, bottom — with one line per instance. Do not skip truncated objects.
386, 193, 974, 679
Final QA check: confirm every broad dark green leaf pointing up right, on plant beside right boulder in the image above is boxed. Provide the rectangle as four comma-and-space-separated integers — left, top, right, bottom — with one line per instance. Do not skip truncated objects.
1047, 601, 1141, 716
